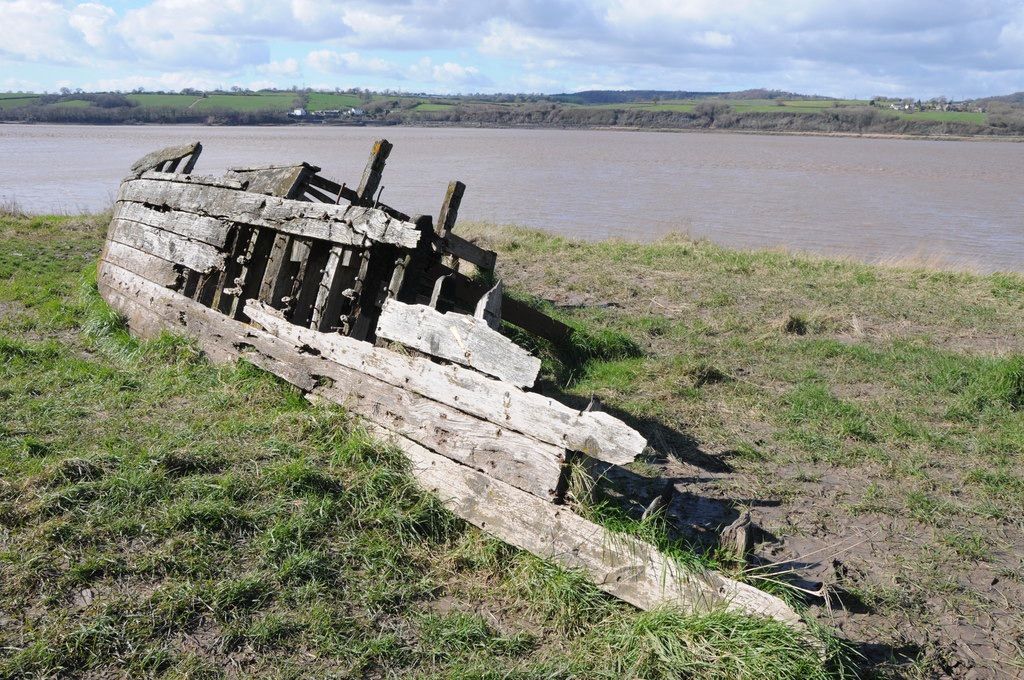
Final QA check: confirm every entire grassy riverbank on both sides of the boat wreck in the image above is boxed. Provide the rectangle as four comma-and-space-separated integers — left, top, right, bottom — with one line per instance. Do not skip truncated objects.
0, 217, 1024, 678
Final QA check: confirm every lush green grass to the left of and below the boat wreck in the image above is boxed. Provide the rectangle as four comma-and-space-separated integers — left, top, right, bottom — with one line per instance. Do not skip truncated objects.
0, 215, 847, 678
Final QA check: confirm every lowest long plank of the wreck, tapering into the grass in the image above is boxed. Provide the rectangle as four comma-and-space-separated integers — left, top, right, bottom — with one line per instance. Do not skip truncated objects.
368, 425, 806, 631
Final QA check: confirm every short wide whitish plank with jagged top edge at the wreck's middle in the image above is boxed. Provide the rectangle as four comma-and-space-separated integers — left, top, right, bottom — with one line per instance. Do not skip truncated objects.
377, 300, 541, 387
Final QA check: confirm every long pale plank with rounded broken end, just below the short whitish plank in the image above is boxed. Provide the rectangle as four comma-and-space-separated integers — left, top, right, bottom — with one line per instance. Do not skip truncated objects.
245, 301, 647, 465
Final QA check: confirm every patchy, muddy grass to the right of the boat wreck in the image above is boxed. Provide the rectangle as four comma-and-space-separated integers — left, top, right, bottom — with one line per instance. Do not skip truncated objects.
461, 225, 1024, 668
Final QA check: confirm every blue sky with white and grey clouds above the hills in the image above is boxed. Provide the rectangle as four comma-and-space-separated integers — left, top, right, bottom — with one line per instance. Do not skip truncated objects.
0, 0, 1024, 99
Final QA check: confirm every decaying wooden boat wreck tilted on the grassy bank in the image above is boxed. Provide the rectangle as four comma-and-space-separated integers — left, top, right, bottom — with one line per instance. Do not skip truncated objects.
98, 140, 802, 628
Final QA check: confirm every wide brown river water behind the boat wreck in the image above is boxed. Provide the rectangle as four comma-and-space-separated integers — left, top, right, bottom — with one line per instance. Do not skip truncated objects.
0, 125, 1024, 271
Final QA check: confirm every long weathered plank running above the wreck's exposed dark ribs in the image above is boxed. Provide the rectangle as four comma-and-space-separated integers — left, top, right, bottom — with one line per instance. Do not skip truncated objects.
118, 179, 421, 248
